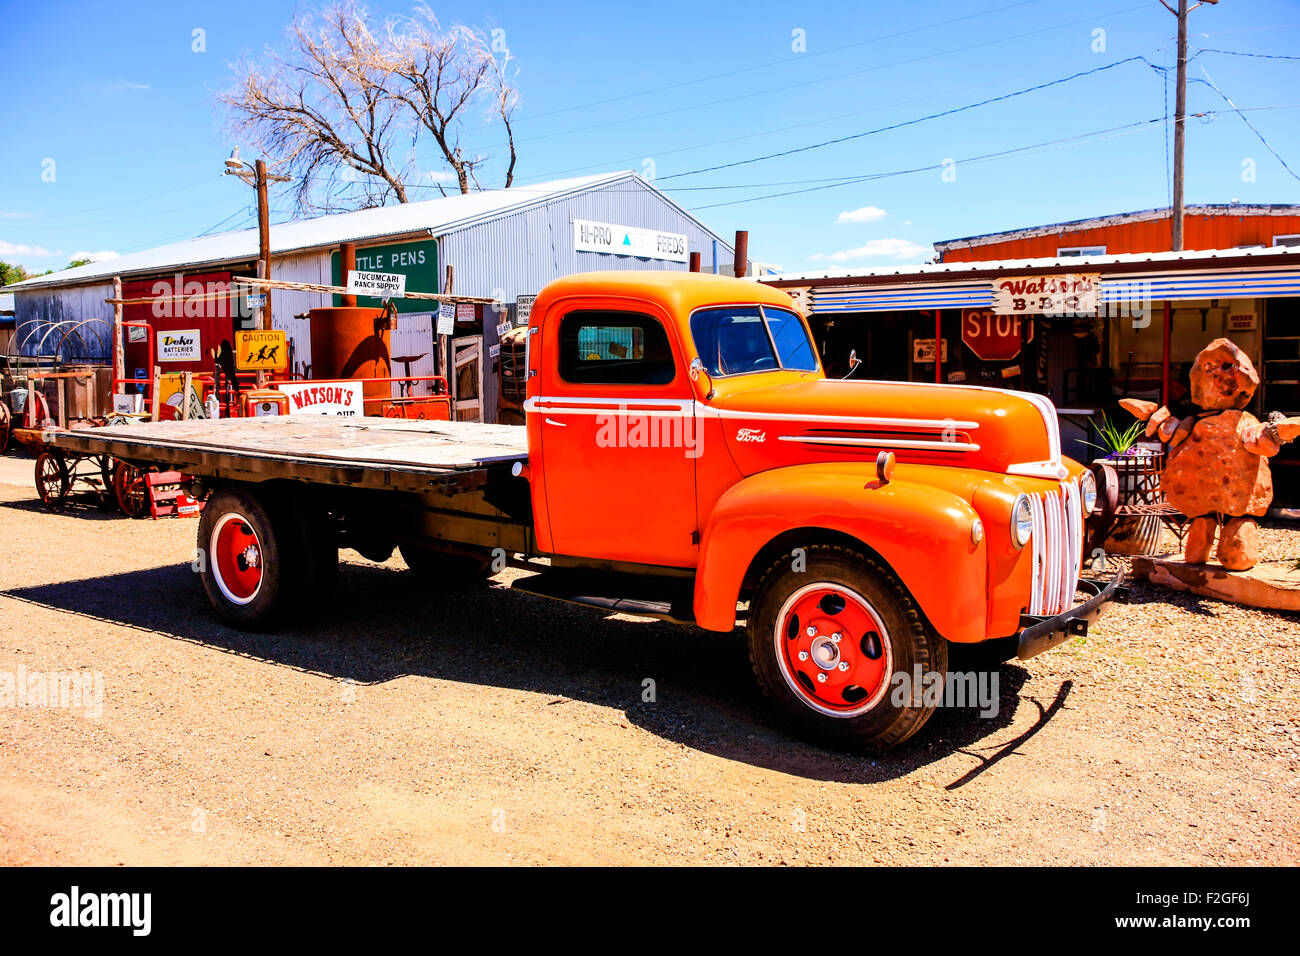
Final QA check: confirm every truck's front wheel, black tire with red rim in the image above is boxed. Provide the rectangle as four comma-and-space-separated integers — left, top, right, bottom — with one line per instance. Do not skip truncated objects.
749, 545, 948, 750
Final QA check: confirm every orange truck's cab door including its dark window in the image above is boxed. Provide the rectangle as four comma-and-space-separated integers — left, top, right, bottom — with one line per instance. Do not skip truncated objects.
529, 299, 701, 567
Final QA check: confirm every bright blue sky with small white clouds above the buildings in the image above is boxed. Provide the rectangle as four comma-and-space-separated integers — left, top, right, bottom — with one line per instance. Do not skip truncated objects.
0, 0, 1300, 277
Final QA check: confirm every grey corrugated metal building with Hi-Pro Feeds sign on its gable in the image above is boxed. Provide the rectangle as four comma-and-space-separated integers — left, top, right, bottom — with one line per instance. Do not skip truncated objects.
8, 170, 732, 419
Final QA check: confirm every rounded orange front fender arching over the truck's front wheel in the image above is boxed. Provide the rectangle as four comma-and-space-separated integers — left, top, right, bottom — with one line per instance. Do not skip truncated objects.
694, 463, 987, 643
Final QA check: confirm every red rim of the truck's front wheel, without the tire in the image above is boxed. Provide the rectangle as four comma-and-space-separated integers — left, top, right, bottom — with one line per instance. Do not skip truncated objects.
774, 583, 893, 717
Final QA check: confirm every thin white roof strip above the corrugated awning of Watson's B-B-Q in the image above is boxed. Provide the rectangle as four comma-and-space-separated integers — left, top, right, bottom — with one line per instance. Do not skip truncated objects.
758, 246, 1300, 285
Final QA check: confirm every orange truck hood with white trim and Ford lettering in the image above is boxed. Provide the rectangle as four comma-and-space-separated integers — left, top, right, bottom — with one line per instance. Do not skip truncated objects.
697, 377, 1067, 479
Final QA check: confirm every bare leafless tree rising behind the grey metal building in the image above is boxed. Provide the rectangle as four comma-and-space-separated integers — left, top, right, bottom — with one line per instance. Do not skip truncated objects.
220, 0, 519, 211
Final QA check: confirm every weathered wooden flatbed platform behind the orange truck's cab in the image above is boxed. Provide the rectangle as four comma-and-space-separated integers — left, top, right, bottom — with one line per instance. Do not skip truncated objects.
49, 415, 528, 492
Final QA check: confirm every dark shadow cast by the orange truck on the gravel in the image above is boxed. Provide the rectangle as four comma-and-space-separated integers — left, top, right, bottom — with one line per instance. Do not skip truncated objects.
0, 563, 1069, 790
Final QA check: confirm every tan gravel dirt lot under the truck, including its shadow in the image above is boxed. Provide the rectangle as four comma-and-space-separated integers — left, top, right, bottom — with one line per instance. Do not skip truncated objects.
0, 460, 1300, 865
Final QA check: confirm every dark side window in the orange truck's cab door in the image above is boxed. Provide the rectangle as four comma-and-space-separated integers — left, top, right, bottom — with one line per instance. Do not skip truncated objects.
559, 310, 677, 385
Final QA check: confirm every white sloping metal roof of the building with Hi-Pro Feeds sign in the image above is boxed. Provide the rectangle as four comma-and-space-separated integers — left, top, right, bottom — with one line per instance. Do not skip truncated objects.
7, 170, 655, 290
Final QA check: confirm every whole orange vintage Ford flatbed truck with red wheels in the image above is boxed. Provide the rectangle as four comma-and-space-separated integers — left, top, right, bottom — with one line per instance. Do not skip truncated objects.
52, 272, 1125, 748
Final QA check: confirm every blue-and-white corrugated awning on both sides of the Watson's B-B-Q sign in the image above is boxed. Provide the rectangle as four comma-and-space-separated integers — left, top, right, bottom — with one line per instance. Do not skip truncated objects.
807, 268, 1300, 315
